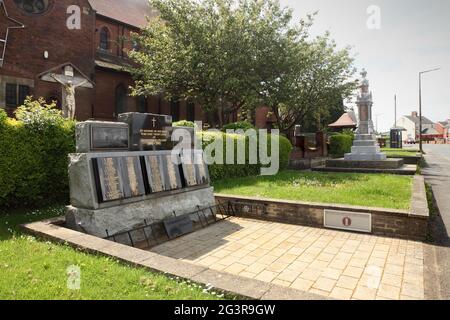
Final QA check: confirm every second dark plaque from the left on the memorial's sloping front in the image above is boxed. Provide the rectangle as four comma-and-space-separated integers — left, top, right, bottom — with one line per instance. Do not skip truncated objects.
120, 157, 145, 198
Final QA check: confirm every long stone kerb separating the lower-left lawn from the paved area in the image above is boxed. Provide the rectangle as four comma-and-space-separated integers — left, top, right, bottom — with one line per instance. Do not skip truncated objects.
22, 220, 320, 300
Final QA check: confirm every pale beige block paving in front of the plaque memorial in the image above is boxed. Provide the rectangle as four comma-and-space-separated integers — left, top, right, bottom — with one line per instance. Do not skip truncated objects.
151, 218, 424, 300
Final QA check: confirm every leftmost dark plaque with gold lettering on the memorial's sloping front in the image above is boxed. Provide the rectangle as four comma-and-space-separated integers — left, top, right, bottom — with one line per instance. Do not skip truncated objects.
94, 158, 125, 202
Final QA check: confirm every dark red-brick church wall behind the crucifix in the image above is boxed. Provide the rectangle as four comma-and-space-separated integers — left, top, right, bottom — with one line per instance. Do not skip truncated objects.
0, 0, 95, 116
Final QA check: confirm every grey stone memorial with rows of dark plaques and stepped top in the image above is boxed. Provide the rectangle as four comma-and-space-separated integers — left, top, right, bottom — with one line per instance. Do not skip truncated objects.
66, 113, 215, 238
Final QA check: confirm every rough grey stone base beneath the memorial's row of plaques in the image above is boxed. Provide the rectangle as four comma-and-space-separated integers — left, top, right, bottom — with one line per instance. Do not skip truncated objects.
66, 187, 216, 238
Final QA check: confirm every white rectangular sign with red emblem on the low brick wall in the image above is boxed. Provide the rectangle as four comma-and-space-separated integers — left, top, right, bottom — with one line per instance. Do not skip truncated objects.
324, 210, 372, 233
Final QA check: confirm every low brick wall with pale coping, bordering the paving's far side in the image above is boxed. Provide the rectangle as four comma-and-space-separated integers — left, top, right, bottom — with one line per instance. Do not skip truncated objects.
215, 176, 429, 240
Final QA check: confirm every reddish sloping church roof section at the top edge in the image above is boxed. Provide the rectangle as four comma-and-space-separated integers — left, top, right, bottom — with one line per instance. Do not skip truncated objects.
89, 0, 155, 28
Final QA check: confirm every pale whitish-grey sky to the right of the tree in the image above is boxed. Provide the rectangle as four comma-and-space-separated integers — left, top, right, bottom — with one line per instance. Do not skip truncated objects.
280, 0, 450, 131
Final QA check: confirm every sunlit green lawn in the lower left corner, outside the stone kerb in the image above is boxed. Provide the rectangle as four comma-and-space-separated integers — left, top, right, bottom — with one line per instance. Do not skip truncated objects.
0, 207, 222, 300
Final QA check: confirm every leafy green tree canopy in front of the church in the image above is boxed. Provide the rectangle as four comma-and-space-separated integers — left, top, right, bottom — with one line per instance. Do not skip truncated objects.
130, 0, 355, 132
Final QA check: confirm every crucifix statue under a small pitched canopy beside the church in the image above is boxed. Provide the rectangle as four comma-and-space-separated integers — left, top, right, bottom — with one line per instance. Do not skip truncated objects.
40, 64, 94, 119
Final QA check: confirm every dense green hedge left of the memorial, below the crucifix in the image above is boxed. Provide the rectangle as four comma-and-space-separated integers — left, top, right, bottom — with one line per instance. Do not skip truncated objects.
0, 100, 75, 207
